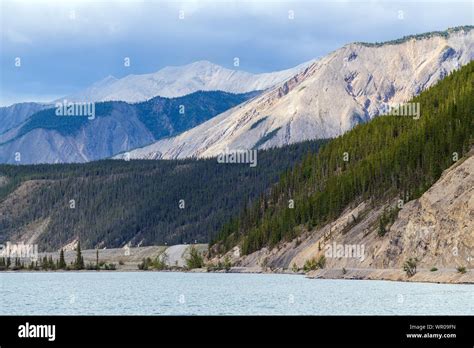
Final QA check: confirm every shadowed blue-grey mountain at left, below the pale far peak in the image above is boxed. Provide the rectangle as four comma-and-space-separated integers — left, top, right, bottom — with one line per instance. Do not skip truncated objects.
0, 91, 257, 164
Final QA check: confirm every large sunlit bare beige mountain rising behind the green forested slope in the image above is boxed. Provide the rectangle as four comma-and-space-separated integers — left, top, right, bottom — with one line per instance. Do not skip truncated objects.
115, 27, 474, 159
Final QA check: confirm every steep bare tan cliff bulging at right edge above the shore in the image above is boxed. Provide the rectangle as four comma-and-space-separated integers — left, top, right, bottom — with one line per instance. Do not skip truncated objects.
386, 153, 474, 268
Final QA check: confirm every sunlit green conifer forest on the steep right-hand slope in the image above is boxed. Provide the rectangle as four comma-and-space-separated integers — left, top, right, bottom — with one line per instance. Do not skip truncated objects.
214, 62, 474, 254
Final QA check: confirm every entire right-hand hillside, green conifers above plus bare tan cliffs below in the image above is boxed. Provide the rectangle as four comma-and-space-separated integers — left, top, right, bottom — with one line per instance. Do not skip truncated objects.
211, 57, 474, 282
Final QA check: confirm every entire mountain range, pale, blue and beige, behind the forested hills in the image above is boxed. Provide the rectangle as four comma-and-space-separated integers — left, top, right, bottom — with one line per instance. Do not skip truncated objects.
0, 26, 474, 164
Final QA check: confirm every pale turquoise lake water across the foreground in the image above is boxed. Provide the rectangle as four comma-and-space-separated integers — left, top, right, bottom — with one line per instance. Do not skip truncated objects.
0, 272, 474, 315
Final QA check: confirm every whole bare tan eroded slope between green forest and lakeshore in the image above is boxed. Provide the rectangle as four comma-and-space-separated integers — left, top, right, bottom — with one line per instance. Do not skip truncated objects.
223, 151, 474, 272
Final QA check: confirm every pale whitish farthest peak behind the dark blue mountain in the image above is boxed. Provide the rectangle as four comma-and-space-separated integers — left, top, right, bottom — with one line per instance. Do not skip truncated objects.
65, 61, 313, 103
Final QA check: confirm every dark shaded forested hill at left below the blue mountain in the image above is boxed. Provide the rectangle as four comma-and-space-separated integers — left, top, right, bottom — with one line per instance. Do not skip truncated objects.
0, 141, 324, 250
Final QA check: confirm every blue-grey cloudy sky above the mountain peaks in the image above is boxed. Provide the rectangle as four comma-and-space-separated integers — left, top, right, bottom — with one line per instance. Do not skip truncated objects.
0, 0, 474, 105
